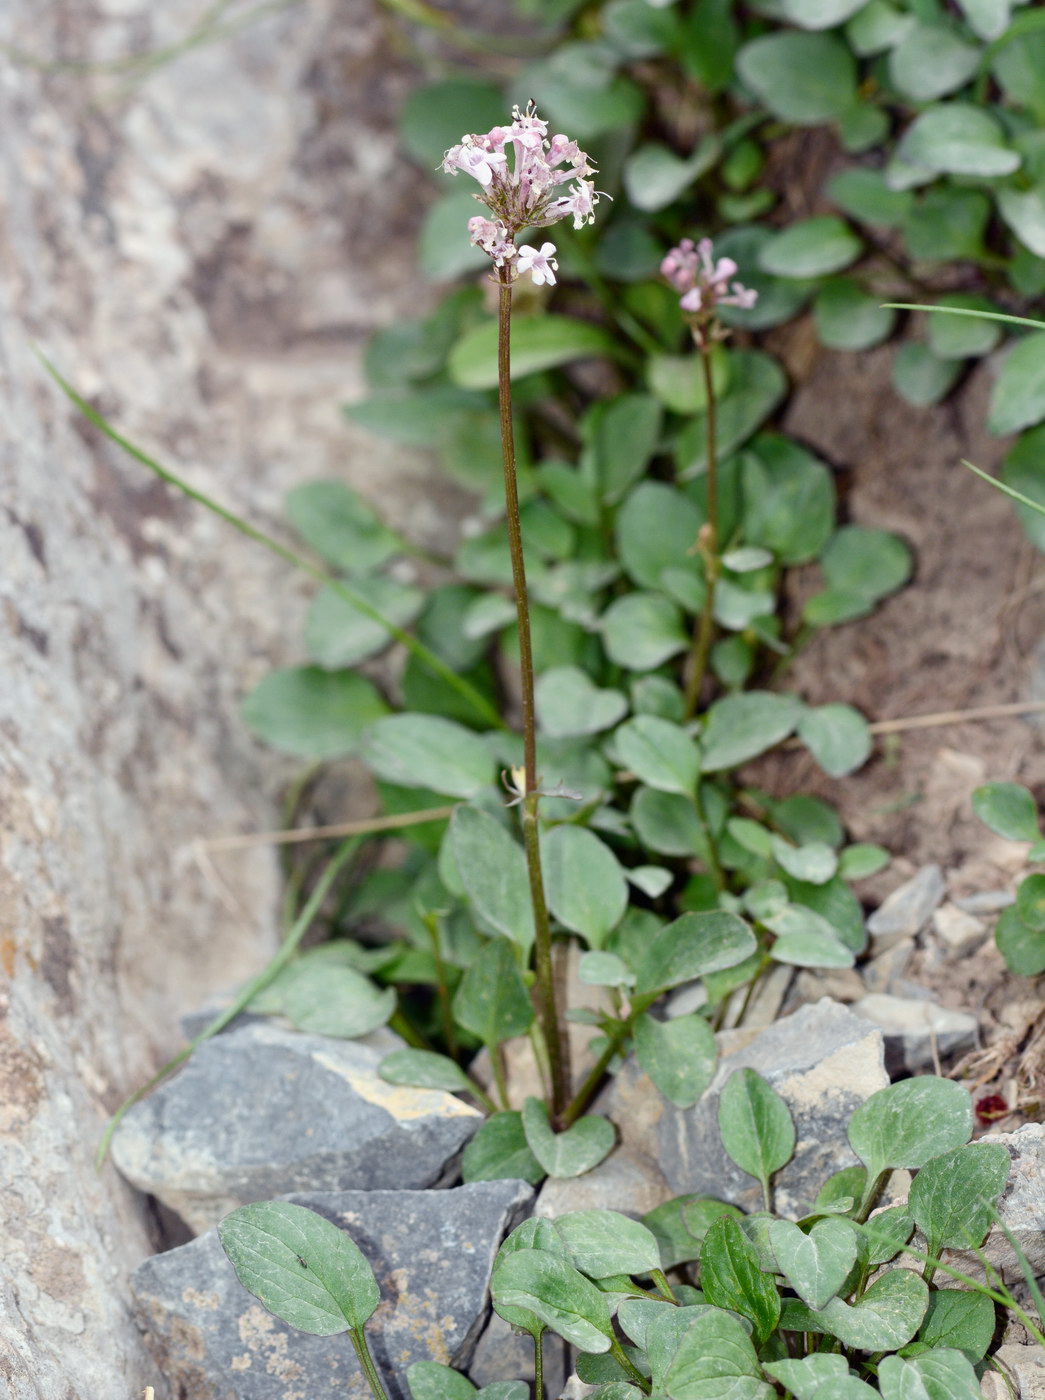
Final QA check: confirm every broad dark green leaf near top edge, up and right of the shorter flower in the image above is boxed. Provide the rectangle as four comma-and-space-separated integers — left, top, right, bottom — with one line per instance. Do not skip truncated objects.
737, 32, 856, 126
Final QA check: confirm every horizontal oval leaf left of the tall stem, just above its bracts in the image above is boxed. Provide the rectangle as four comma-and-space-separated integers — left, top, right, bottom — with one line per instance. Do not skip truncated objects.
360, 714, 493, 797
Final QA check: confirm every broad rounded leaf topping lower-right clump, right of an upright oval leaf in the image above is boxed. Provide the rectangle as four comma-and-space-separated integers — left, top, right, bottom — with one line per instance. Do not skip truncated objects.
849, 1075, 972, 1182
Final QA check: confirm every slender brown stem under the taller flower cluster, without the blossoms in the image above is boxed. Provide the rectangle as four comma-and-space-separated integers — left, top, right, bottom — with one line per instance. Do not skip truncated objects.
497, 278, 570, 1121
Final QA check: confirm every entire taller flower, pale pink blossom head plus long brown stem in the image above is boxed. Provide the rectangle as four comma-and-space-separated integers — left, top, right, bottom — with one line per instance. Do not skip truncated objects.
443, 102, 598, 1123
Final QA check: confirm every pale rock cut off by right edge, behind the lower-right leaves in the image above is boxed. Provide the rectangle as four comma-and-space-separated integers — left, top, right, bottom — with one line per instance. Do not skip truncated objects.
944, 1123, 1045, 1287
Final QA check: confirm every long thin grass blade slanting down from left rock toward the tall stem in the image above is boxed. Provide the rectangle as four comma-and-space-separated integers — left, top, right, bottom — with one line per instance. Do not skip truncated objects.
36, 350, 506, 729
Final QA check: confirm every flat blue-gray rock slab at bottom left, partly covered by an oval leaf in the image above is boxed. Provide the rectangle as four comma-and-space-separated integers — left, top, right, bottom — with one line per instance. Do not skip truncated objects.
133, 1182, 534, 1400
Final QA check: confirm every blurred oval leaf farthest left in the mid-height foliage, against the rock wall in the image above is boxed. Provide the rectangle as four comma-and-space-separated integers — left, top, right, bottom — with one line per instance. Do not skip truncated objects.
241, 666, 388, 759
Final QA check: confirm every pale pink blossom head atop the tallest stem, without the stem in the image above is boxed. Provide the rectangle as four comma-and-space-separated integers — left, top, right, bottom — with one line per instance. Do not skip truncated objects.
443, 102, 598, 284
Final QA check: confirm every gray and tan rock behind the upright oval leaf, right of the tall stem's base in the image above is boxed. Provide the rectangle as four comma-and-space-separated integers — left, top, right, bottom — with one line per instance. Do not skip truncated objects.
600, 997, 890, 1215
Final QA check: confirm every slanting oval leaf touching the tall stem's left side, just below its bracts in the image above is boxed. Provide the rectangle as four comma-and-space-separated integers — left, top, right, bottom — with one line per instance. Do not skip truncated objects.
450, 806, 534, 951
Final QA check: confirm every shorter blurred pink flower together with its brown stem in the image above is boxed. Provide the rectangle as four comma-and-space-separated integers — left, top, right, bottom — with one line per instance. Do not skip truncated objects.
660, 238, 758, 718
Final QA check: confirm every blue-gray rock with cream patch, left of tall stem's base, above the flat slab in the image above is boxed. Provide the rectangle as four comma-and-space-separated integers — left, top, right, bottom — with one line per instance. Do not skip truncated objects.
112, 1023, 482, 1232
